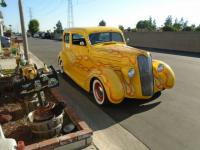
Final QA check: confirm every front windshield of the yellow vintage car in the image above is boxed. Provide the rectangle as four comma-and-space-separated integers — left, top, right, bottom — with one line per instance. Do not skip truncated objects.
89, 32, 124, 45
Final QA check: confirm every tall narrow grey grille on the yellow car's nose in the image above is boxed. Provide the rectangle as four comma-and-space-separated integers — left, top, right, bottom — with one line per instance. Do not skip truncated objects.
137, 55, 154, 96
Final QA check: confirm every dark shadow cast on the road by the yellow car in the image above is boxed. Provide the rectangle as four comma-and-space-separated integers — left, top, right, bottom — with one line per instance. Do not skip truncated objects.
60, 72, 161, 125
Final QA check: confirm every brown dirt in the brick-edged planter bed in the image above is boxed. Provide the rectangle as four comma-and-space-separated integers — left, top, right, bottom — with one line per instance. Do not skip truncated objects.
0, 90, 76, 145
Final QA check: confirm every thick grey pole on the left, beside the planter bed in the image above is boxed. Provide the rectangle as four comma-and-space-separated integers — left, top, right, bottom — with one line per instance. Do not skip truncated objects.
18, 0, 29, 63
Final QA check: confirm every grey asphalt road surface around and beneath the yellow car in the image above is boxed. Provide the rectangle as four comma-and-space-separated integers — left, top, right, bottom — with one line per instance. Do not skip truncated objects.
29, 39, 200, 150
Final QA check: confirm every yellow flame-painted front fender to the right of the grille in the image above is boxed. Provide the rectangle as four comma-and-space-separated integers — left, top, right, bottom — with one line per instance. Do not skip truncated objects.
153, 60, 175, 92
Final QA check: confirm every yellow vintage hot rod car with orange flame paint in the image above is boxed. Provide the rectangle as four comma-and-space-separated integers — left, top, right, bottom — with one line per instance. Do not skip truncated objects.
58, 27, 175, 105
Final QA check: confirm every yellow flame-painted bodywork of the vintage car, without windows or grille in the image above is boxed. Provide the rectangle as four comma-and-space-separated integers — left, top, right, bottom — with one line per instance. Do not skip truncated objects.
58, 27, 175, 104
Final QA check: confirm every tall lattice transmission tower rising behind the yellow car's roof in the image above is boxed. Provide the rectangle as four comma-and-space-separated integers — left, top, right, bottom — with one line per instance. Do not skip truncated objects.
67, 0, 74, 28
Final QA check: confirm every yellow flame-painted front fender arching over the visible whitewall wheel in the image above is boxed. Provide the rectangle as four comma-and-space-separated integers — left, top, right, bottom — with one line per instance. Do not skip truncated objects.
88, 67, 125, 104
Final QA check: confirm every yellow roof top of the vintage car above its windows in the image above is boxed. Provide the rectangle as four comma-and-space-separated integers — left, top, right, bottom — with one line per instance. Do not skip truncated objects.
64, 26, 121, 33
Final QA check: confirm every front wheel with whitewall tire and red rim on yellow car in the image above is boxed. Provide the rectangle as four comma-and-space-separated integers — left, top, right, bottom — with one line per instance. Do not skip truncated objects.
92, 79, 108, 106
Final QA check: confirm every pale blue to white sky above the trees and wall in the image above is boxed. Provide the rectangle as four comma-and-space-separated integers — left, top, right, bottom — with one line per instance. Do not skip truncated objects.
0, 0, 200, 32
